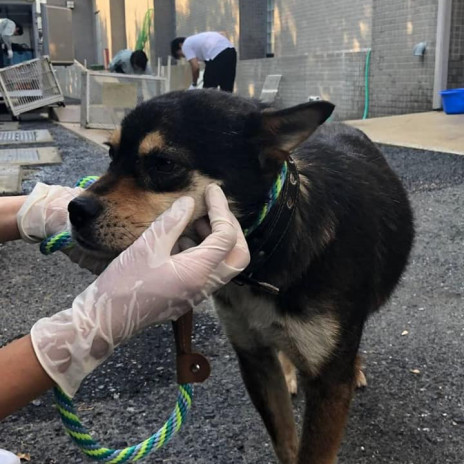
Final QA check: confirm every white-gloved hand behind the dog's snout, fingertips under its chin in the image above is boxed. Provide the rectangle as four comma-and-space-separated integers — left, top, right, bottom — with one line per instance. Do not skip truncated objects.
17, 182, 108, 274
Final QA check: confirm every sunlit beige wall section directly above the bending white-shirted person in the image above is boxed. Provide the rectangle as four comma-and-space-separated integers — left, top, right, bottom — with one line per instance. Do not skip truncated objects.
176, 0, 240, 49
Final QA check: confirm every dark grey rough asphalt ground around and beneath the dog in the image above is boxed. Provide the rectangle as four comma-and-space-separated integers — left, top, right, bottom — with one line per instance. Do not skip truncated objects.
0, 122, 464, 464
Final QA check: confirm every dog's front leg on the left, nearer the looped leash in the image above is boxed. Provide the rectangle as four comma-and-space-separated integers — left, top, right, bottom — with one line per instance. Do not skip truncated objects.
234, 346, 298, 464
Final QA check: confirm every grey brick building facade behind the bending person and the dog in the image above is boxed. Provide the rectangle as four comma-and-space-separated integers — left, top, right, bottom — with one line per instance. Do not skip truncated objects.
154, 0, 464, 119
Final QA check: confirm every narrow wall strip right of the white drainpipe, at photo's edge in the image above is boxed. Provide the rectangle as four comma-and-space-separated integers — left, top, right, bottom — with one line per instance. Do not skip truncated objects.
448, 0, 464, 89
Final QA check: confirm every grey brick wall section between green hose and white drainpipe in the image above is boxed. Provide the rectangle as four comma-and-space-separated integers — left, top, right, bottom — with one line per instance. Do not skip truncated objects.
369, 0, 437, 116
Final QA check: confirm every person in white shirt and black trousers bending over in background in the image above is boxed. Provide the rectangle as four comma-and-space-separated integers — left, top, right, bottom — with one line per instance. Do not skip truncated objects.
171, 32, 237, 92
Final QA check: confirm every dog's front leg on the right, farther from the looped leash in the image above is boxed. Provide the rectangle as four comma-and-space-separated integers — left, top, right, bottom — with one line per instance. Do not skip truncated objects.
298, 368, 354, 464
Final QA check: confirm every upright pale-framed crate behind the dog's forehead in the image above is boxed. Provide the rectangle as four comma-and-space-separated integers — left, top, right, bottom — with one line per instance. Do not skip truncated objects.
81, 70, 169, 129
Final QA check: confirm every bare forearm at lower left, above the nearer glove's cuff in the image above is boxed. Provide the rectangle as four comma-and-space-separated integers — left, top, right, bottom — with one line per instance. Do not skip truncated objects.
0, 335, 54, 420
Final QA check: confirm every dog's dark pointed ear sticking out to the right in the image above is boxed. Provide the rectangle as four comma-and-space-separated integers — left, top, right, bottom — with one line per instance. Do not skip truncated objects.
261, 101, 335, 154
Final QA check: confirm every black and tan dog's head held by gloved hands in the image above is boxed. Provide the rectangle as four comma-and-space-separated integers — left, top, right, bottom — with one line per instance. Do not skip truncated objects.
69, 90, 333, 256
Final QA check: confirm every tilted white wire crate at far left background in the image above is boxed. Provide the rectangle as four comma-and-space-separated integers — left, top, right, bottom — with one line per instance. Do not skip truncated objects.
0, 56, 64, 117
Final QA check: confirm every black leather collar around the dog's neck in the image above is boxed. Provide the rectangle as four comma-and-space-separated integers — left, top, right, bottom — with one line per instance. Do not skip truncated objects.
233, 157, 300, 295
